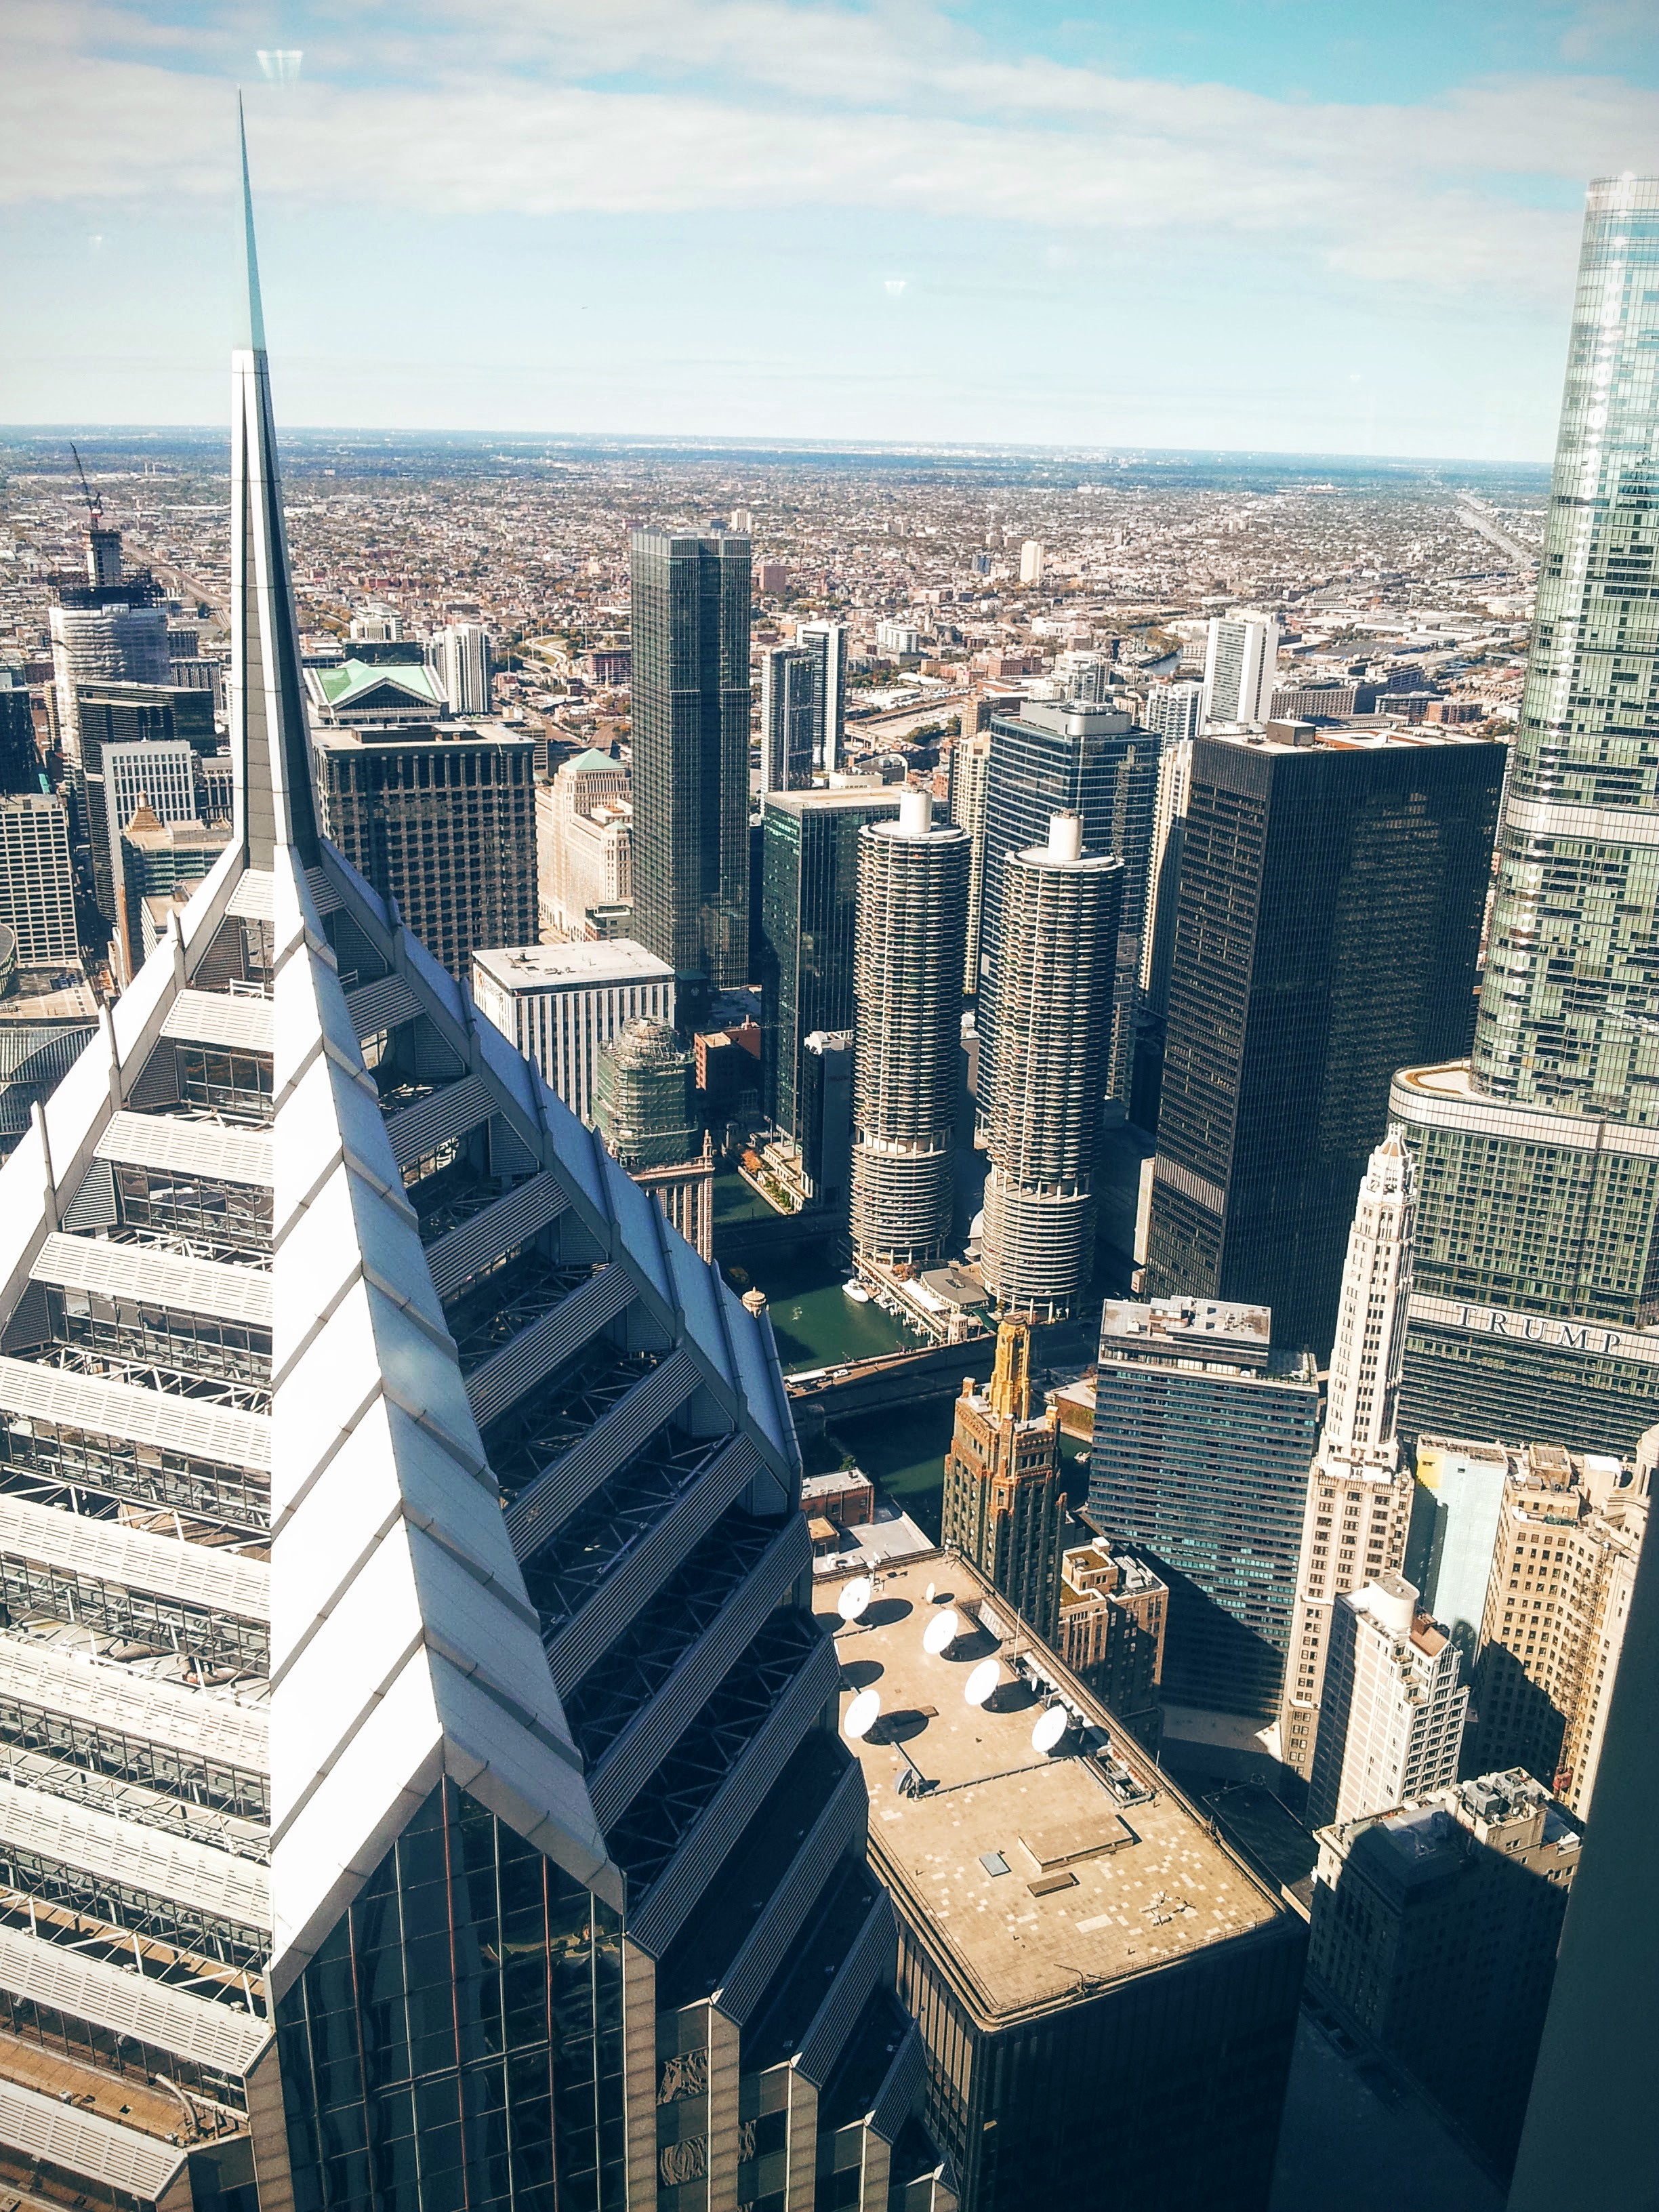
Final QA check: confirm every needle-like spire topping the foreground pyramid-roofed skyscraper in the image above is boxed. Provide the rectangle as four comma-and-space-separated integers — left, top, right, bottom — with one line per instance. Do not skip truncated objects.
230, 102, 316, 867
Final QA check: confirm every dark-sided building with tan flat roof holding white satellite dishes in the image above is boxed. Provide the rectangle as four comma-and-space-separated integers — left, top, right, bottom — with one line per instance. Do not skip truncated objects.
819, 1555, 1305, 2212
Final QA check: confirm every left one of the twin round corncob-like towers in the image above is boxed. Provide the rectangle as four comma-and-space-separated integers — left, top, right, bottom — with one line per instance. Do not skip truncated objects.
852, 792, 969, 1267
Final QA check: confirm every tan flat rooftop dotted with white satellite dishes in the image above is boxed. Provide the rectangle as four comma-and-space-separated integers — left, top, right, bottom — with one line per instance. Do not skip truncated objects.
814, 1553, 1283, 2026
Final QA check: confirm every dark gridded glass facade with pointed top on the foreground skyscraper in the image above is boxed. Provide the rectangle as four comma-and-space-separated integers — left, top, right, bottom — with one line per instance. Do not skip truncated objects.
276, 1781, 623, 2212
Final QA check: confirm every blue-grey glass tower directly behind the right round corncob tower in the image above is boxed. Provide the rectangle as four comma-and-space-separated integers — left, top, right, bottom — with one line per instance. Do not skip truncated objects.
978, 699, 1164, 1106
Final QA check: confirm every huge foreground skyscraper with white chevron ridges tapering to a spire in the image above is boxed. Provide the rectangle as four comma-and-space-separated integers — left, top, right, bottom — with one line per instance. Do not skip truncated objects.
0, 151, 945, 2212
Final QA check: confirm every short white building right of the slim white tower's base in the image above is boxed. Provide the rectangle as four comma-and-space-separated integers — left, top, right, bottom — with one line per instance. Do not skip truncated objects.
1307, 1570, 1469, 1827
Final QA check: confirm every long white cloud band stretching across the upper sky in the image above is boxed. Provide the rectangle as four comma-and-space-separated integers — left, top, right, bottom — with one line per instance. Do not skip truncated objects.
0, 0, 1659, 316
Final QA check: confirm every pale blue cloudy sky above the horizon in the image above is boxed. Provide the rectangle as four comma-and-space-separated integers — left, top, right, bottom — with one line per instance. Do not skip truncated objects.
0, 0, 1659, 460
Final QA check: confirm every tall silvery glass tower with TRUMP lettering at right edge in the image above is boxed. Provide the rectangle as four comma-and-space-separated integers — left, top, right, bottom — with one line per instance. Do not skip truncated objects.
1389, 177, 1659, 1451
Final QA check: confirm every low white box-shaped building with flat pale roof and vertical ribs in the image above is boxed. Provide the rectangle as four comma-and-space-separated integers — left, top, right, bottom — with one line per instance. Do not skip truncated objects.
473, 938, 675, 1122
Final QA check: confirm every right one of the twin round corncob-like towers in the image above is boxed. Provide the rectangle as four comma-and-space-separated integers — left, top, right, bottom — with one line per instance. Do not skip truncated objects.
980, 814, 1124, 1321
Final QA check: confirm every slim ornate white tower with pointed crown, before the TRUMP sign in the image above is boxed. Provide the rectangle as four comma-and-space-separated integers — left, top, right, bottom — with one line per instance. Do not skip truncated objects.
1279, 1130, 1418, 1781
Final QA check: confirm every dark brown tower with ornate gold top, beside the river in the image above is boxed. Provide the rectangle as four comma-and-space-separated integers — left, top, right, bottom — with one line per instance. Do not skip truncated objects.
940, 1321, 1066, 1643
